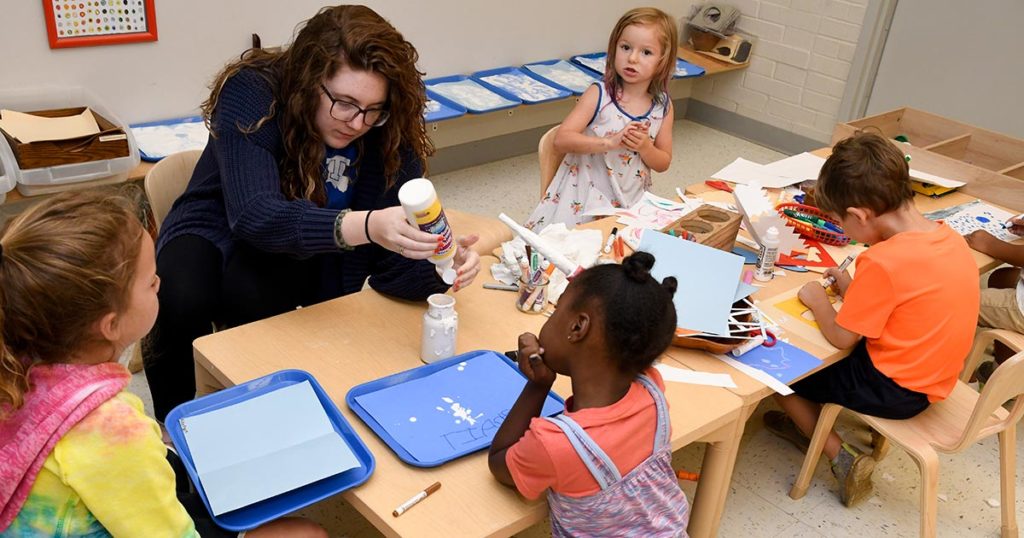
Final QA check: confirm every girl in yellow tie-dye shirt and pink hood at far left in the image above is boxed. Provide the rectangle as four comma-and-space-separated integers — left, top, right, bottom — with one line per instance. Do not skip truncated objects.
0, 192, 324, 537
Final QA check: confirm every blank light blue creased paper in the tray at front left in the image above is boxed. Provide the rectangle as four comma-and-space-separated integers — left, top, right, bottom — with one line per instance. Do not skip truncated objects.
180, 381, 359, 515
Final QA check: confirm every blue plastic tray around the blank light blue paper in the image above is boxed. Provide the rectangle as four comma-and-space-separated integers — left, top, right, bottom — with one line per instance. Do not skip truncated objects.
166, 370, 376, 531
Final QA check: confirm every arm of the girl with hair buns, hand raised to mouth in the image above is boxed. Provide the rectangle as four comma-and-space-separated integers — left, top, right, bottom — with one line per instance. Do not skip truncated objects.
487, 333, 556, 488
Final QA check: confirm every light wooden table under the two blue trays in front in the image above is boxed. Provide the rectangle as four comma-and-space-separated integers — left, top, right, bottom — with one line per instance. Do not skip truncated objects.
195, 260, 744, 537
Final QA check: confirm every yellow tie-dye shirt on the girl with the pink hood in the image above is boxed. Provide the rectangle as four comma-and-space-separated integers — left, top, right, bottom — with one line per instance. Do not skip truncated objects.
0, 391, 199, 538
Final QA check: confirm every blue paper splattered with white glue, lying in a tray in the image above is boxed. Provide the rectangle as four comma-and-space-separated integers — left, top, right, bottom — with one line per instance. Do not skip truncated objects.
355, 354, 564, 462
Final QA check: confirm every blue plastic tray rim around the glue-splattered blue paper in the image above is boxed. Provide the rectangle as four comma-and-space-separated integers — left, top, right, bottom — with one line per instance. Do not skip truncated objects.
345, 350, 565, 467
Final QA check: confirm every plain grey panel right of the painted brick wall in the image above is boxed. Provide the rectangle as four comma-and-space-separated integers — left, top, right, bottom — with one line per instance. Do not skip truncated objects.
867, 0, 1024, 138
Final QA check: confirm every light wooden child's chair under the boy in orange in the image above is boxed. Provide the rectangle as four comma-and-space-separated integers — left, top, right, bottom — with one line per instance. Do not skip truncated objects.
790, 329, 1024, 538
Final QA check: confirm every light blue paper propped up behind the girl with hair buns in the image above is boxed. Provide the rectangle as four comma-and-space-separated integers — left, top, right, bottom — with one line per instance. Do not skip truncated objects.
639, 230, 743, 335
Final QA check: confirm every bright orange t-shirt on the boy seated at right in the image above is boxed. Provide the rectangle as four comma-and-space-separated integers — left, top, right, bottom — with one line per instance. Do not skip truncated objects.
836, 222, 981, 402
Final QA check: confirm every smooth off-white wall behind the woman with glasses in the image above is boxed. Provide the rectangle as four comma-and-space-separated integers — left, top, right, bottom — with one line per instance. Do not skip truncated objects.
6, 0, 686, 123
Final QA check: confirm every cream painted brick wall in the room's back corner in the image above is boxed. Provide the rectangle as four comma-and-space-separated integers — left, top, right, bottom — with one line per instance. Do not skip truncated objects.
684, 0, 867, 142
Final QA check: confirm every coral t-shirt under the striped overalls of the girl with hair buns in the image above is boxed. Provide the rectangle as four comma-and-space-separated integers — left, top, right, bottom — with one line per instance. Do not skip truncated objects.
505, 368, 665, 499
